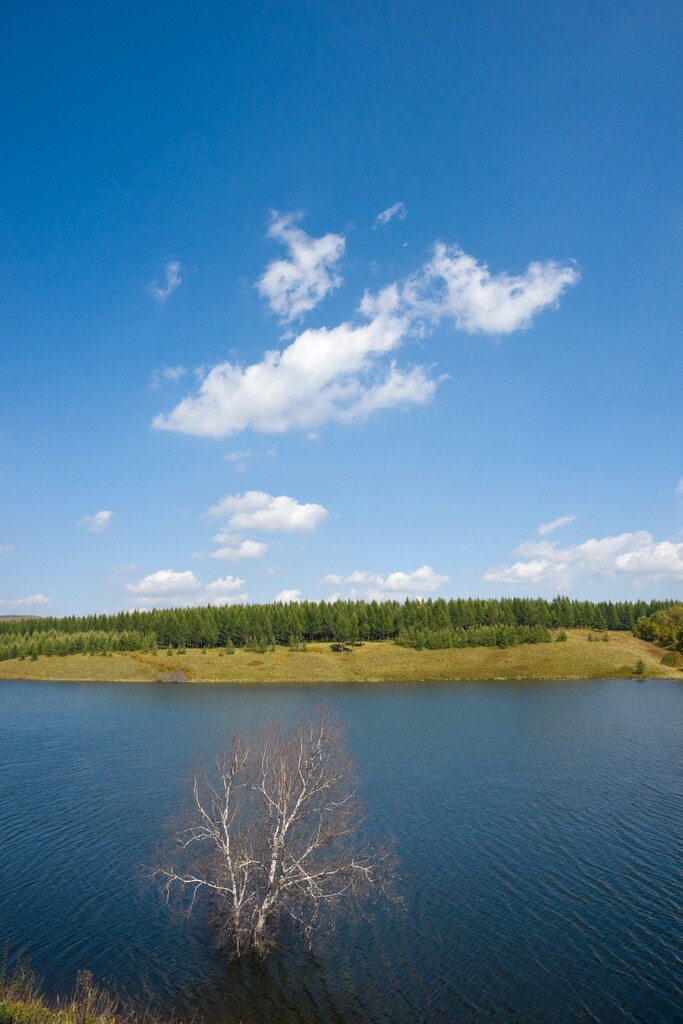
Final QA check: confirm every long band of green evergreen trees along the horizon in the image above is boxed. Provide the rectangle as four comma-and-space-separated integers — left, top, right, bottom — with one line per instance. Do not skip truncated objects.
0, 597, 674, 656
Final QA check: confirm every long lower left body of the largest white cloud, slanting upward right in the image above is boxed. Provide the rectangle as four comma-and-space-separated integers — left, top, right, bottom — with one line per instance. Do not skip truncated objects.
153, 286, 437, 437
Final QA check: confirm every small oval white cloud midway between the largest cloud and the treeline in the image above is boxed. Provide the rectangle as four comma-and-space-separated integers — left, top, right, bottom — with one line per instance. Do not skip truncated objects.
206, 490, 330, 534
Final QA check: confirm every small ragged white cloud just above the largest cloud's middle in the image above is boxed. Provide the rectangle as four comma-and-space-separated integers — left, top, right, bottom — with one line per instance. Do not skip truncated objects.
256, 212, 345, 323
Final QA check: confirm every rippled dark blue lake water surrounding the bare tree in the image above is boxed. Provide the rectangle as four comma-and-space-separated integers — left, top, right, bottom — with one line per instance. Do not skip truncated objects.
0, 680, 683, 1024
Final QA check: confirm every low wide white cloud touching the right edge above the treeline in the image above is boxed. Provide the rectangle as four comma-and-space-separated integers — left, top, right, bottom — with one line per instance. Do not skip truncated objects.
484, 529, 683, 589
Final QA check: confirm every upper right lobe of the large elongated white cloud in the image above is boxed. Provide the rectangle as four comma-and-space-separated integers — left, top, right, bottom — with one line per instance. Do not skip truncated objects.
405, 242, 580, 335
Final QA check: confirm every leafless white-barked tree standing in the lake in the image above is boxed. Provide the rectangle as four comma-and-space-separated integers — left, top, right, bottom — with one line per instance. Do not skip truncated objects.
155, 709, 394, 957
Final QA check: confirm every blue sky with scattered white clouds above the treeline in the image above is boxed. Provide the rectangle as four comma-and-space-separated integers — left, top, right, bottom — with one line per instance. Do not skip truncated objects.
0, 0, 683, 614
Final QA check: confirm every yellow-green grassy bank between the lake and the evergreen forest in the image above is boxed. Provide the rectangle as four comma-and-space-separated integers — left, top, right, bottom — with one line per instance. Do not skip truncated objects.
0, 630, 683, 683
